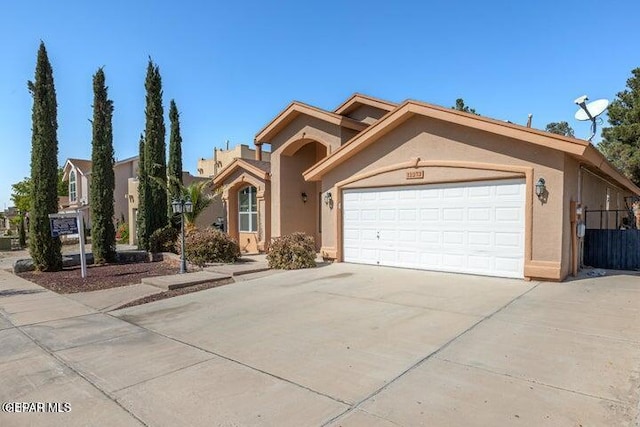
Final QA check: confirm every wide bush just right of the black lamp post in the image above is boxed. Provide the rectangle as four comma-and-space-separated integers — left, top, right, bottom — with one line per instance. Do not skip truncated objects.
177, 227, 240, 267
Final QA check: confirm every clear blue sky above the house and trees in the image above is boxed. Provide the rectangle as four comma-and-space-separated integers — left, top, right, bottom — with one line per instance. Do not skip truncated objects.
0, 0, 640, 208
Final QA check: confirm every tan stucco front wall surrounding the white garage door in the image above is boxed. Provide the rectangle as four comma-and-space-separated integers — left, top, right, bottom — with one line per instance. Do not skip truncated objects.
322, 117, 564, 279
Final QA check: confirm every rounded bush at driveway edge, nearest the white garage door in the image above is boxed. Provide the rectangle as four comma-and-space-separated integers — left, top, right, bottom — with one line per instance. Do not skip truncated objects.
267, 233, 316, 270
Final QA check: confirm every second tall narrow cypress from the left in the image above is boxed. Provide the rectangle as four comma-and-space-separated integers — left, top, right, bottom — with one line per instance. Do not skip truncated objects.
89, 68, 116, 264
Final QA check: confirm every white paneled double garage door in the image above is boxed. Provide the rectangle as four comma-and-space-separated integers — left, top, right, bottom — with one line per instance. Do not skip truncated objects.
343, 180, 525, 278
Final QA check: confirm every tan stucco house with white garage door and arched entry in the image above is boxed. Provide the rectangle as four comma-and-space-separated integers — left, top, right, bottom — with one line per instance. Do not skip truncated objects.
214, 94, 640, 280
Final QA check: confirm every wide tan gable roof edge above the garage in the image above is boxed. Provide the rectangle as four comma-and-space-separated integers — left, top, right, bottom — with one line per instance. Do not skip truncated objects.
303, 100, 640, 194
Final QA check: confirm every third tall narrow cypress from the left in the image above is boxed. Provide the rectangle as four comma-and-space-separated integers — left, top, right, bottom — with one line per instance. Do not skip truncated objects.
140, 59, 168, 249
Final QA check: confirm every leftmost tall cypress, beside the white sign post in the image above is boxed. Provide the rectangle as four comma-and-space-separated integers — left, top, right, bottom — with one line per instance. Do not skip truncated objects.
27, 42, 62, 271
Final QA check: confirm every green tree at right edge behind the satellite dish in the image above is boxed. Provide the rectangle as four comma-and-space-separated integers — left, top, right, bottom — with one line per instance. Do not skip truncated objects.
598, 68, 640, 185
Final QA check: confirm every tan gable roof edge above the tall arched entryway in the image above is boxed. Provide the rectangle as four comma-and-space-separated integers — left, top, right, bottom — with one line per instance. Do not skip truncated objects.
255, 101, 367, 144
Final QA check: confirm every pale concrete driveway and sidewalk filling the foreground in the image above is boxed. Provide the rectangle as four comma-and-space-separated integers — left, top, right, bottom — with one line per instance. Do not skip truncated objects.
0, 264, 640, 426
